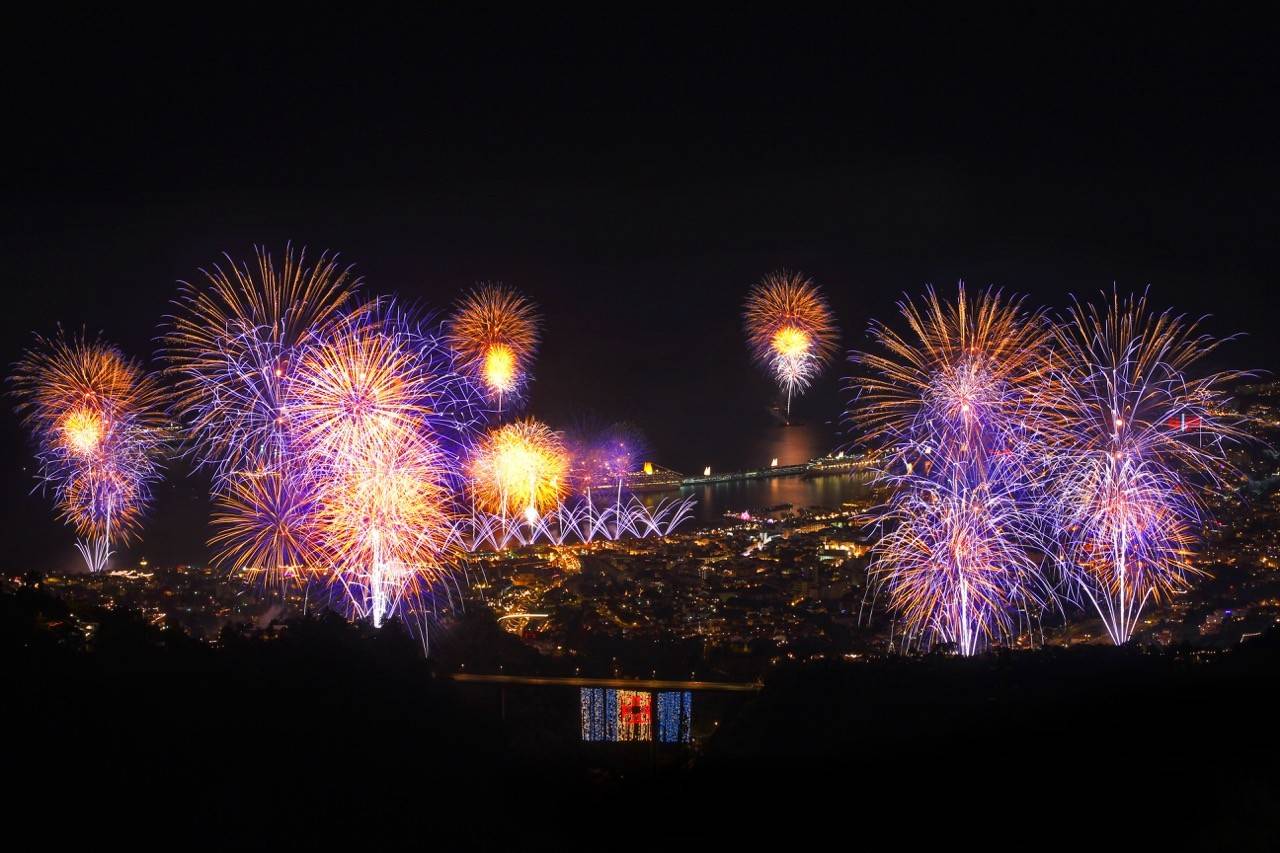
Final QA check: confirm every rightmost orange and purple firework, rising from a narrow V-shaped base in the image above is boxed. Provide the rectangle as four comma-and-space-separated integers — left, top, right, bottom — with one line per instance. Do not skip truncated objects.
1046, 293, 1243, 643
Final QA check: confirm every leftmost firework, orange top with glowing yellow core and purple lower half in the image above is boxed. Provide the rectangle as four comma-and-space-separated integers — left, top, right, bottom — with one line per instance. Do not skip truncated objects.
12, 333, 166, 571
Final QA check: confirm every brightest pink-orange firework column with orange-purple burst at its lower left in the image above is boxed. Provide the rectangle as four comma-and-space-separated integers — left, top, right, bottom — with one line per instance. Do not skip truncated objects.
212, 302, 483, 625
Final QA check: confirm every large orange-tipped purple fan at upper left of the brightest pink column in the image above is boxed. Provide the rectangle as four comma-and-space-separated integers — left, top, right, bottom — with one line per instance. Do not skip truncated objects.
161, 247, 360, 487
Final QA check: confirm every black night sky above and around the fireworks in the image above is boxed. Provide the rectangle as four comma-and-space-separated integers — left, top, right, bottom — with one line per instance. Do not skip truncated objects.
0, 6, 1280, 566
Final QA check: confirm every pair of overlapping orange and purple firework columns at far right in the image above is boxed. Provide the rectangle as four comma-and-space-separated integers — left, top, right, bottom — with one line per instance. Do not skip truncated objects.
849, 286, 1243, 653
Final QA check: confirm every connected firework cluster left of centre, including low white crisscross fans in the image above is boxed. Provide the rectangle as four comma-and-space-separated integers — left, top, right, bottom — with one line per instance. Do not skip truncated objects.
175, 252, 691, 625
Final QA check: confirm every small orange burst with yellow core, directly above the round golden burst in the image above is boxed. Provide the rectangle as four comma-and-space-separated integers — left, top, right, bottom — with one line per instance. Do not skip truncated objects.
449, 283, 539, 411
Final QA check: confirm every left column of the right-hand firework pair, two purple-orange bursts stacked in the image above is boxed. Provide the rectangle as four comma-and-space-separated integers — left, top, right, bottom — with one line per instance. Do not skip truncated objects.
847, 284, 1057, 654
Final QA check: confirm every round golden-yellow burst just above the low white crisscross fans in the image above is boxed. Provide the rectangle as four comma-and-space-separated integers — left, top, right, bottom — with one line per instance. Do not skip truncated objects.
471, 419, 568, 520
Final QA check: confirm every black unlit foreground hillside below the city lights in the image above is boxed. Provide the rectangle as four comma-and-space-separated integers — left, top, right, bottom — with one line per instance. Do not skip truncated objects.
0, 588, 1280, 850
